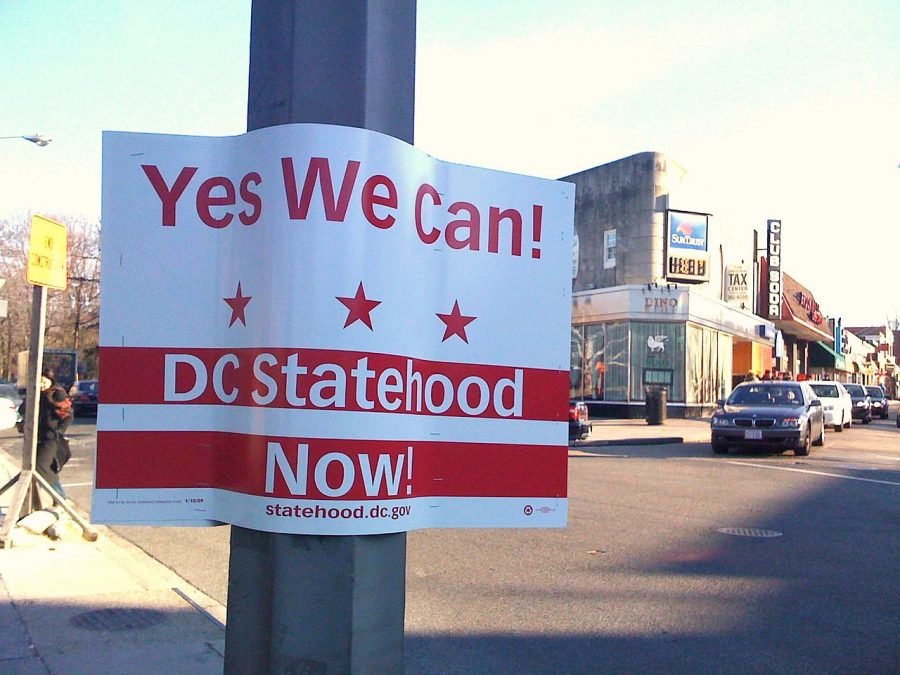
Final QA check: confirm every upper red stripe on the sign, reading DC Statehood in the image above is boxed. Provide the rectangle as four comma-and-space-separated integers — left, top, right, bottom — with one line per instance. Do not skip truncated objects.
100, 347, 569, 421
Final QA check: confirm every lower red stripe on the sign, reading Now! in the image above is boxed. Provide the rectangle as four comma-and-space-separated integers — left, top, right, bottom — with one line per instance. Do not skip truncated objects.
96, 431, 568, 499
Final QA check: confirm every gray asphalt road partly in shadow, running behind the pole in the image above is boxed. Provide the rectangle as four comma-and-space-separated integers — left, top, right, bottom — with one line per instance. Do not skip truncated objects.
0, 414, 900, 674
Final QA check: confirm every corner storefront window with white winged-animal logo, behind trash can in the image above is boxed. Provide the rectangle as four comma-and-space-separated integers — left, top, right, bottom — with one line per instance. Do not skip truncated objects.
631, 322, 684, 401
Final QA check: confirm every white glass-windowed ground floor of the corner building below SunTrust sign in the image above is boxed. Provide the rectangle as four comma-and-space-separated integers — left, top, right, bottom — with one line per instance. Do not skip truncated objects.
570, 284, 773, 418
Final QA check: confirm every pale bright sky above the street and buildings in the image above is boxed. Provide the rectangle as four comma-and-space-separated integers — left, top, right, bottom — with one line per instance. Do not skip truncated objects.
0, 0, 900, 325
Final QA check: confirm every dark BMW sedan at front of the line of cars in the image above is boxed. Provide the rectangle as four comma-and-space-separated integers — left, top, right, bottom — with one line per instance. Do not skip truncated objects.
710, 381, 825, 455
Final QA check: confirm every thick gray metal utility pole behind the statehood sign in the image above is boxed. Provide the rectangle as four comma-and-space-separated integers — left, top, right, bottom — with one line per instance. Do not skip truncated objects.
225, 0, 416, 674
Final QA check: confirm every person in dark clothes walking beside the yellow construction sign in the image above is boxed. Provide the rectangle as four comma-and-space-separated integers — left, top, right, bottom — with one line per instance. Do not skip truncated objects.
35, 368, 72, 508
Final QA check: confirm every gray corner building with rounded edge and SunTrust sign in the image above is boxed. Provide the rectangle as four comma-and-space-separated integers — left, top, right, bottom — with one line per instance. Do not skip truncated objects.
562, 152, 775, 417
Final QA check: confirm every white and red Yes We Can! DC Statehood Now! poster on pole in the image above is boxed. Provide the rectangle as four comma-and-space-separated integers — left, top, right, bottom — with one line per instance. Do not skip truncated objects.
92, 124, 575, 535
